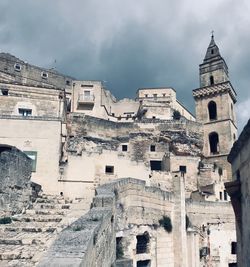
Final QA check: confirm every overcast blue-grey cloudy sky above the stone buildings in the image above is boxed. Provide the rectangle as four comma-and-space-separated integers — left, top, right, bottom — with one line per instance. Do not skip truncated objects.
0, 0, 250, 130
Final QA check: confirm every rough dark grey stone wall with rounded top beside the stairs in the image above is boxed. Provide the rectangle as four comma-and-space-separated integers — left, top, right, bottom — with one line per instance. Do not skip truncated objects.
0, 145, 31, 213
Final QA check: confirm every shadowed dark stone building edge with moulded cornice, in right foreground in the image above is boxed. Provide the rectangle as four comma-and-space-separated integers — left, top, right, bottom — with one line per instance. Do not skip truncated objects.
226, 121, 250, 267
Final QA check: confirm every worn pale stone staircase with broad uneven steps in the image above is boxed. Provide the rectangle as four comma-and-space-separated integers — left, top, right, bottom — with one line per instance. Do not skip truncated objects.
0, 195, 90, 267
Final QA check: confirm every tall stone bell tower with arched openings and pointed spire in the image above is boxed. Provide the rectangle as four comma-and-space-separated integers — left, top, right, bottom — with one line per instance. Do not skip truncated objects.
193, 34, 237, 179
